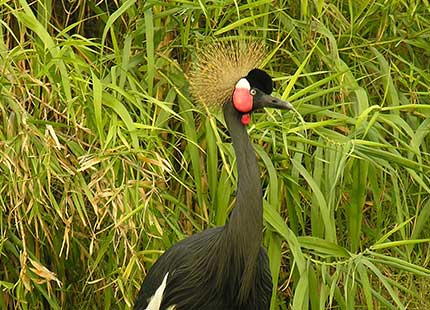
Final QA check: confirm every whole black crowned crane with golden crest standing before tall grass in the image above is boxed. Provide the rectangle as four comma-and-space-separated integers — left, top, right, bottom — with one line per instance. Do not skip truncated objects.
134, 43, 292, 310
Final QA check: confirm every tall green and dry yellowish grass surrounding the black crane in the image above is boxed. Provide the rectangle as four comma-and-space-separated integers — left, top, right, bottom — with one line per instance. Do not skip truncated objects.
0, 0, 430, 309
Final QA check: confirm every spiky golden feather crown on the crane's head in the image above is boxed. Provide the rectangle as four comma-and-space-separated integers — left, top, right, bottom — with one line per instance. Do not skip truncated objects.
188, 41, 266, 107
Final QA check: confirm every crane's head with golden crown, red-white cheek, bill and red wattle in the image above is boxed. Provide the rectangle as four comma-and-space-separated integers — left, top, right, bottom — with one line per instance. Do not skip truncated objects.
189, 42, 293, 125
